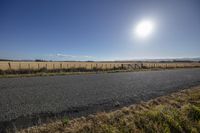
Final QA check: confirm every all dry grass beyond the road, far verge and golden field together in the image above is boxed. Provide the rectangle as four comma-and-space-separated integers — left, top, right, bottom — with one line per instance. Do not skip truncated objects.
0, 61, 200, 78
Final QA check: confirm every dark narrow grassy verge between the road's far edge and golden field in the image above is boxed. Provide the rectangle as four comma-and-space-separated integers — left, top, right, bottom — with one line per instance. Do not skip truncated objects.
0, 68, 198, 78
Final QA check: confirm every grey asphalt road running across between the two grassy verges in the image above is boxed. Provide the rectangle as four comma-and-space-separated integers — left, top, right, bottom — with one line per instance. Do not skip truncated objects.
0, 68, 200, 128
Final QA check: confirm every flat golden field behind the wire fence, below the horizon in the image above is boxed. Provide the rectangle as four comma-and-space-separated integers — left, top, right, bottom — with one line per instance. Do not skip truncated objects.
0, 61, 200, 70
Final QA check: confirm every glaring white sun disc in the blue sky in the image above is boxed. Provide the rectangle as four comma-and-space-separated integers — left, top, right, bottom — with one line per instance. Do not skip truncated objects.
135, 20, 154, 38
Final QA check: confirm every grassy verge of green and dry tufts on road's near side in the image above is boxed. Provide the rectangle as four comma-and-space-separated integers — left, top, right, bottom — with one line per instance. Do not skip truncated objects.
19, 86, 200, 133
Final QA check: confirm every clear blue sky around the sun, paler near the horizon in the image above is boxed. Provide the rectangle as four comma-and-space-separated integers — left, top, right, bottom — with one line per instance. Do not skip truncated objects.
0, 0, 200, 61
